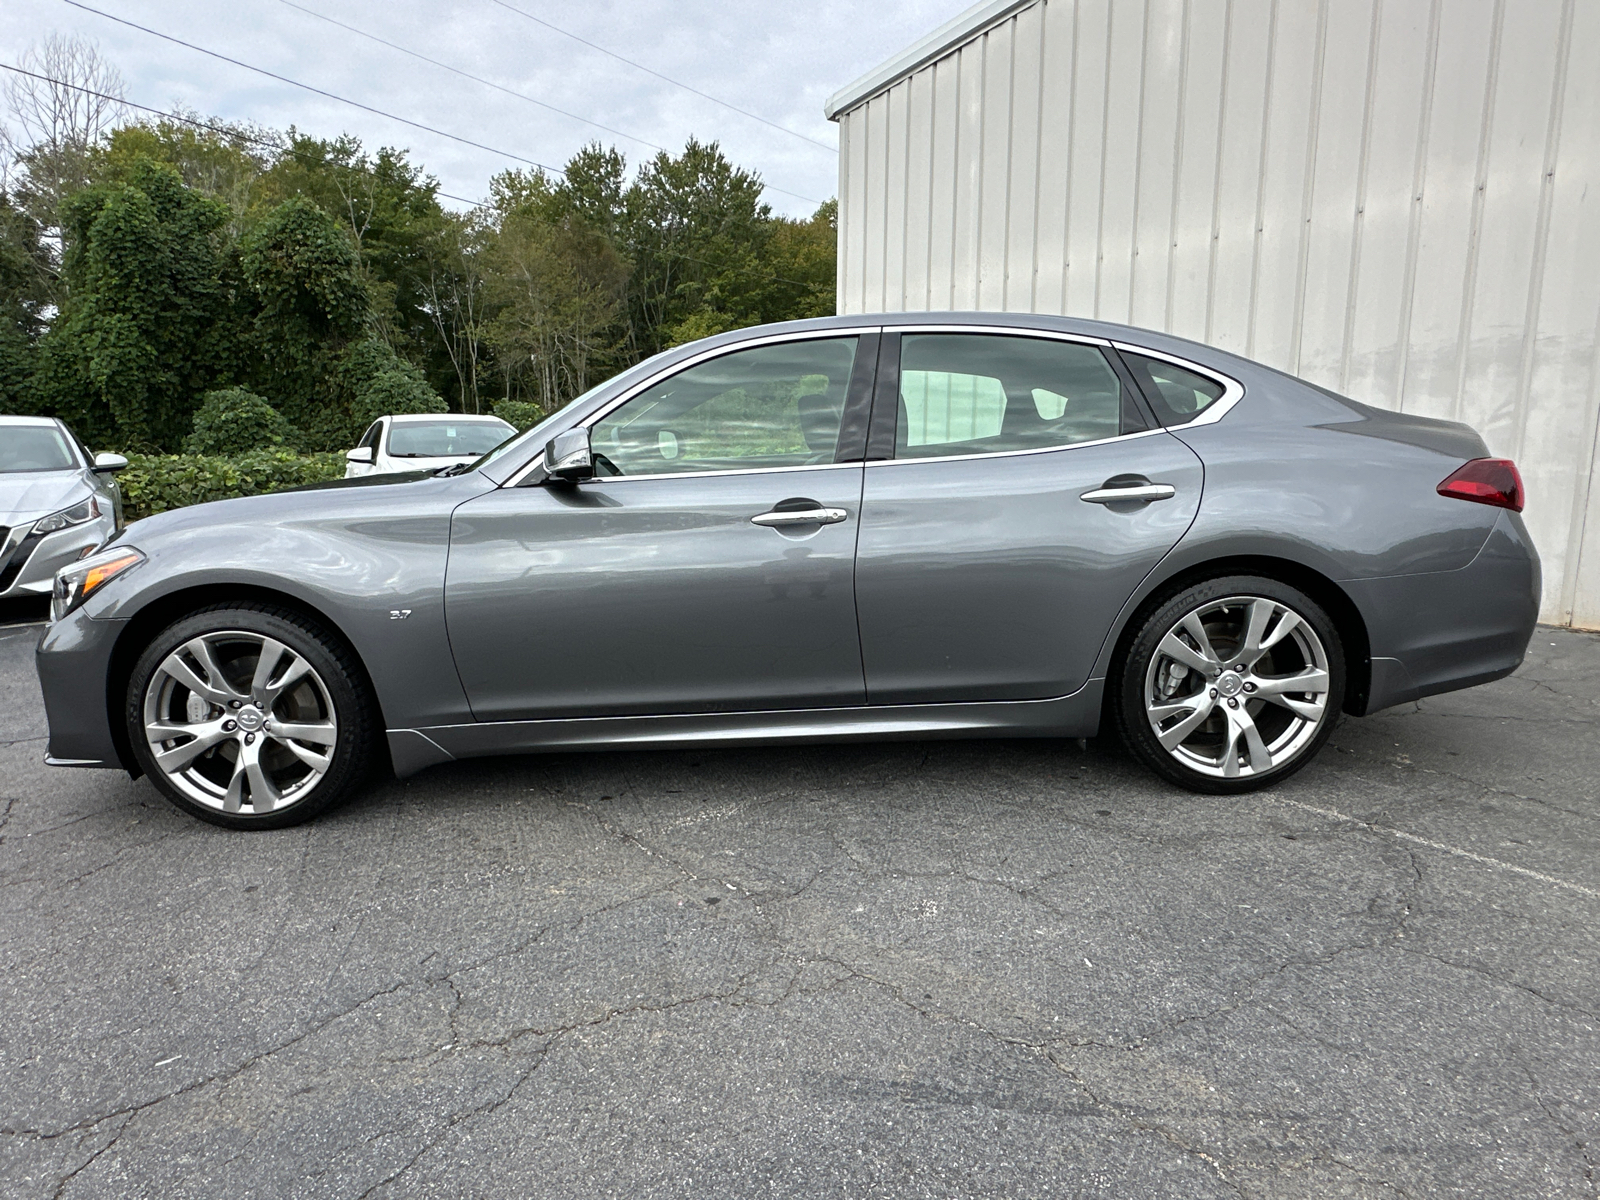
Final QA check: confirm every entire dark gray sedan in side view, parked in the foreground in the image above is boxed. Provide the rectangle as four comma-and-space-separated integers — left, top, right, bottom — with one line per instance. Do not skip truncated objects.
38, 314, 1539, 829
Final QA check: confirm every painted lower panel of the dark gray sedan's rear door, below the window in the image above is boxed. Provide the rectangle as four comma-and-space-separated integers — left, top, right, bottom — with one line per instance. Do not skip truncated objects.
856, 430, 1203, 704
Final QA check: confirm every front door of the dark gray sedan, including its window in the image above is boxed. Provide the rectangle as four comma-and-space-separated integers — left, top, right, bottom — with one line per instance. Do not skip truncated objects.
445, 338, 875, 720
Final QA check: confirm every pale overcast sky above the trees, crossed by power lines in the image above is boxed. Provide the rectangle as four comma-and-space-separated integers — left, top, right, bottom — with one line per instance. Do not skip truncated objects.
0, 0, 968, 214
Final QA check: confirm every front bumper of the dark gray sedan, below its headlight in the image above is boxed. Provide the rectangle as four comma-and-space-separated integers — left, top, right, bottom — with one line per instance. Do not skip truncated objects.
34, 608, 131, 770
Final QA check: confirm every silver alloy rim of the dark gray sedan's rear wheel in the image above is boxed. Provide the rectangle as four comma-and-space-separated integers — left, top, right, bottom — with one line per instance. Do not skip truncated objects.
1144, 595, 1330, 779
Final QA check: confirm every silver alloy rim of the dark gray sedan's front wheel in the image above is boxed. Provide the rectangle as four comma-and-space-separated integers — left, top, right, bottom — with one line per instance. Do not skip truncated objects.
144, 630, 339, 816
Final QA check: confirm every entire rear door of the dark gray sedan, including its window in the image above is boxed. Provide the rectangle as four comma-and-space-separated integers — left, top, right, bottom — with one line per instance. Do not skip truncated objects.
856, 330, 1203, 704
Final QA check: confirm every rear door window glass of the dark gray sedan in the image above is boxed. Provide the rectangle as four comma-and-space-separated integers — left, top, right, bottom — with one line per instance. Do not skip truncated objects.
896, 333, 1142, 458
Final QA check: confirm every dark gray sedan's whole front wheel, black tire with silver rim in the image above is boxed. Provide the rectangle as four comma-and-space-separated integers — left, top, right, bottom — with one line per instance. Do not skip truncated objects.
123, 603, 379, 829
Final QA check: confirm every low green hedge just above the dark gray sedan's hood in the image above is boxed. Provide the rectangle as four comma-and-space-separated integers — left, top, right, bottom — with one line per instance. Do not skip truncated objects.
117, 450, 344, 520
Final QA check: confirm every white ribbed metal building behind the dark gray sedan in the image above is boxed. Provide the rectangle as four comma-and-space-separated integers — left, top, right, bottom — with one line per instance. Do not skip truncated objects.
827, 0, 1600, 627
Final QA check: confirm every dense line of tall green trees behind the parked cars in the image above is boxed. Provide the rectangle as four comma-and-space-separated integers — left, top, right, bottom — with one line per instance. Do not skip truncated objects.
0, 42, 837, 451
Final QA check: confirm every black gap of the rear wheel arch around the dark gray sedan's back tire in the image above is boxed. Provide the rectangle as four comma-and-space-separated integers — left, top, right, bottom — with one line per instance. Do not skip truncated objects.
1102, 554, 1373, 726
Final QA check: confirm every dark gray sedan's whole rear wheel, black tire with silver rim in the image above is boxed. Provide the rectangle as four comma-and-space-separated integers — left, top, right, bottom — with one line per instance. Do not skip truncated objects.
1112, 576, 1344, 795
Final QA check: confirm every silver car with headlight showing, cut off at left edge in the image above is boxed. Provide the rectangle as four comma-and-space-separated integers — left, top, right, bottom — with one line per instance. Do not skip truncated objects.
0, 416, 128, 600
